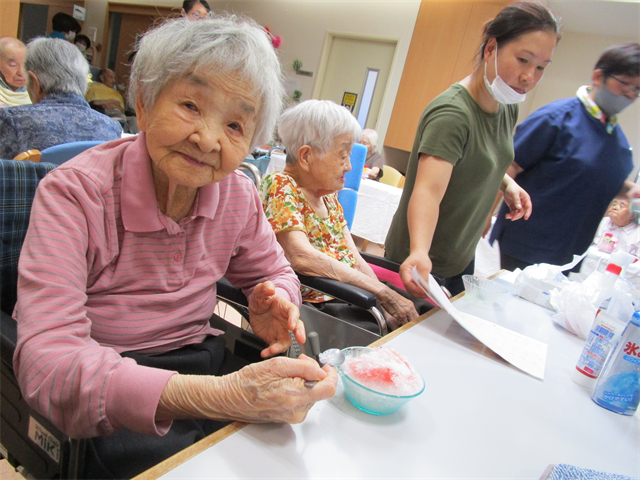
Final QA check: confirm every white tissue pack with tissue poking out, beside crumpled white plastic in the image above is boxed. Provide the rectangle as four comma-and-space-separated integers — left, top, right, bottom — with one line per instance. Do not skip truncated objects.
513, 255, 584, 310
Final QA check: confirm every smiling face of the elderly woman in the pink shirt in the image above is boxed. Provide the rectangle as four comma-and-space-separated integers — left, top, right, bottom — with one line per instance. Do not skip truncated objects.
137, 73, 260, 188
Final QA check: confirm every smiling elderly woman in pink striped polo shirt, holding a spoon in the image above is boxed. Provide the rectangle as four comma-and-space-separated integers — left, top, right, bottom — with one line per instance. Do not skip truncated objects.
14, 18, 337, 479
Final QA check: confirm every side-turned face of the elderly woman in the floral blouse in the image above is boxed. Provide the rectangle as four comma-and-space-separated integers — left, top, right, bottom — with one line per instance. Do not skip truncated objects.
309, 134, 354, 192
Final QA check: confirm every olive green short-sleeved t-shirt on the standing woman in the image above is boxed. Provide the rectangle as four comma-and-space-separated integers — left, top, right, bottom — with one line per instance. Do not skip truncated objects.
385, 83, 518, 278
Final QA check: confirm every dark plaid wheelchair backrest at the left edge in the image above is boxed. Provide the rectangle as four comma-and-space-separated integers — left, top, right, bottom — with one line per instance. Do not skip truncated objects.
0, 160, 56, 315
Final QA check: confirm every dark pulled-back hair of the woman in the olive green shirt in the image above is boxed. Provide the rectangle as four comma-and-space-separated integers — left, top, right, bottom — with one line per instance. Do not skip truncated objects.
478, 2, 560, 60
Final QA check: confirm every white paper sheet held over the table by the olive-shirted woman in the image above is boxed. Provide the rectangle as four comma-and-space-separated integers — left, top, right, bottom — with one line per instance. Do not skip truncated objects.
411, 267, 547, 380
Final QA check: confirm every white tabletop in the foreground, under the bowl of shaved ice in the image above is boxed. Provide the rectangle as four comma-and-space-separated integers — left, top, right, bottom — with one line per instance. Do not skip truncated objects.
141, 274, 640, 480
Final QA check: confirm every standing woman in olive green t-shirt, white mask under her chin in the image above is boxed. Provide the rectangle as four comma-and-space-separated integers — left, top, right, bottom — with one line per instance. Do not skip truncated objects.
385, 2, 559, 297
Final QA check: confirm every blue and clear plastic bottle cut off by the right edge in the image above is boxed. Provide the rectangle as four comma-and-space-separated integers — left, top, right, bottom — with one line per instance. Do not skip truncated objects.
592, 310, 640, 415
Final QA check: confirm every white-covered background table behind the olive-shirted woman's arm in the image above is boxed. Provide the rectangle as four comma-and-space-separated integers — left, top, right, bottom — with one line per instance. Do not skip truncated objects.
351, 180, 402, 248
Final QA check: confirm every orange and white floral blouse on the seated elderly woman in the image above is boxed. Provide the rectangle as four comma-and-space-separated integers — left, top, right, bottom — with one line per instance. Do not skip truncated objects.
260, 172, 356, 303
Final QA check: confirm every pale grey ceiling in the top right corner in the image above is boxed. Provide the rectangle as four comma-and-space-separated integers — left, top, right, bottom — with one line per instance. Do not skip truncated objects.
547, 0, 640, 41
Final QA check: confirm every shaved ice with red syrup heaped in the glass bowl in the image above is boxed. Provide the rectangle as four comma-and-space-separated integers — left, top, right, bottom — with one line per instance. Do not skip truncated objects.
342, 347, 422, 397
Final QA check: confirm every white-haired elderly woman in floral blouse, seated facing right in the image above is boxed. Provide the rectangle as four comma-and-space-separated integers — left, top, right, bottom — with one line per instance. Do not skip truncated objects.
261, 100, 418, 331
